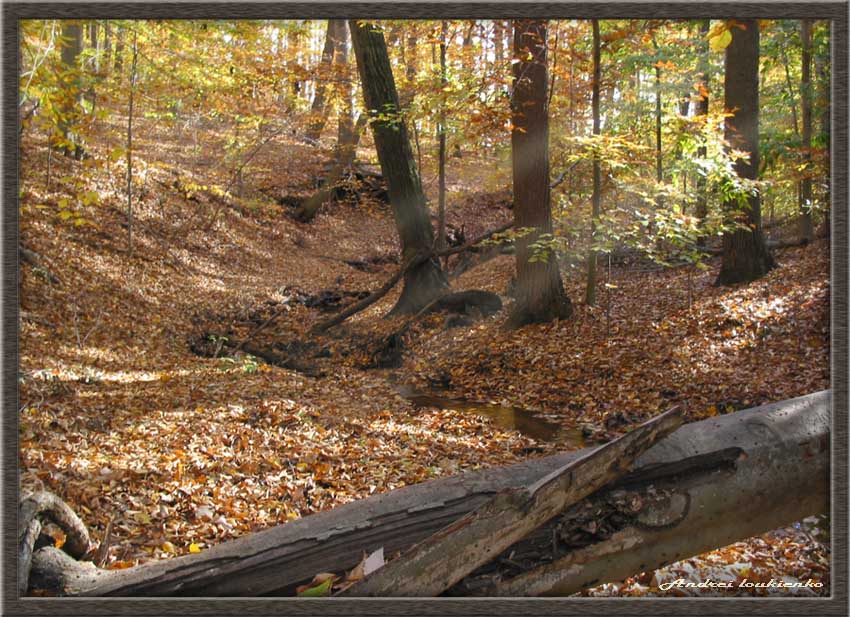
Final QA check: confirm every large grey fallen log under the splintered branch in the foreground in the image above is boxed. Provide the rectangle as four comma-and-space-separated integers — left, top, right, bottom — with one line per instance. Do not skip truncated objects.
30, 391, 830, 596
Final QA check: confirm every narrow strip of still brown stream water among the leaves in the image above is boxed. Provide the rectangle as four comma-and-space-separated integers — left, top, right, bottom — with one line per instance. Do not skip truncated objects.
394, 383, 585, 448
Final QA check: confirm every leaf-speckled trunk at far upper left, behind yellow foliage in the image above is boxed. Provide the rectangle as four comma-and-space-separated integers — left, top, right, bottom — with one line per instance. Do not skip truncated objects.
56, 20, 83, 159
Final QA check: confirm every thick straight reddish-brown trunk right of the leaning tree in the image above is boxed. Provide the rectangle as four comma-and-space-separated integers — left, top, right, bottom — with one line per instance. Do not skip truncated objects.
509, 19, 572, 327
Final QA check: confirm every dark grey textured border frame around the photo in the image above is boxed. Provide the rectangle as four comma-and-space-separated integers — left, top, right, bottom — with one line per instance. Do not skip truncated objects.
0, 0, 848, 617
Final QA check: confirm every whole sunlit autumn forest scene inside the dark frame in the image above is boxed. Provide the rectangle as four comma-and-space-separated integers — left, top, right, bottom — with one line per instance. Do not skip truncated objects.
16, 18, 833, 602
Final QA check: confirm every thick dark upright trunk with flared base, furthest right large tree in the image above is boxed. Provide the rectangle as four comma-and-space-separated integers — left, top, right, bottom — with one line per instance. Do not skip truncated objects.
717, 19, 775, 285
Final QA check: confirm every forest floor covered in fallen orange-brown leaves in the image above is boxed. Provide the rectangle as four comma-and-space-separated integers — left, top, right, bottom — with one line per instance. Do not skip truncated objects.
19, 113, 830, 595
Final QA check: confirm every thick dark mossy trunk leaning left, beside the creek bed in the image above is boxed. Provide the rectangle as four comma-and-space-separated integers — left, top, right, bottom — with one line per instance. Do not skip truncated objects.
349, 20, 448, 314
